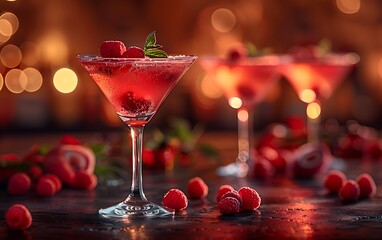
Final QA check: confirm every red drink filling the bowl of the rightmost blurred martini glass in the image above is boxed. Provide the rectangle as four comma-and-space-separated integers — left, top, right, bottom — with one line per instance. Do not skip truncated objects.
282, 54, 356, 101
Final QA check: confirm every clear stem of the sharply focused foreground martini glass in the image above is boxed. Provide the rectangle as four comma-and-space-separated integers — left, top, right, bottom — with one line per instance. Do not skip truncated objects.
129, 126, 147, 201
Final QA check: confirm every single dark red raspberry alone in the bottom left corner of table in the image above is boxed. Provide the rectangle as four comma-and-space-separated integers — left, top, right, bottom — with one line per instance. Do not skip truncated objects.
5, 204, 32, 230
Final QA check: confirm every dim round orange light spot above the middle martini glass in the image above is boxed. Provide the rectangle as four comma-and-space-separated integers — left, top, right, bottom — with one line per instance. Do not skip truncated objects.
211, 8, 236, 33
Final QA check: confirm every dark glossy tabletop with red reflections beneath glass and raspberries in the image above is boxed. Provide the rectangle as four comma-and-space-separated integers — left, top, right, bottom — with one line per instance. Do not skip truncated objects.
0, 133, 382, 240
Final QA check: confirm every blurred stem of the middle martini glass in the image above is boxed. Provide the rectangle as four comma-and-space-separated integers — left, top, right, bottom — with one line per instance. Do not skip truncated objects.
236, 107, 253, 176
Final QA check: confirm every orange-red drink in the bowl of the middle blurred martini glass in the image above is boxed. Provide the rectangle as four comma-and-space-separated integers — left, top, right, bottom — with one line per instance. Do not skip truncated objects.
201, 56, 280, 106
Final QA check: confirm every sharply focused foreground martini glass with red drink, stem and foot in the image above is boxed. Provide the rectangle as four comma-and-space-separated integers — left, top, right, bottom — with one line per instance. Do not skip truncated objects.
77, 55, 196, 220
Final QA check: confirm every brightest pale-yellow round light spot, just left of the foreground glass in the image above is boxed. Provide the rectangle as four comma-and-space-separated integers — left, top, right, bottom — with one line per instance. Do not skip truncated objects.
53, 68, 78, 93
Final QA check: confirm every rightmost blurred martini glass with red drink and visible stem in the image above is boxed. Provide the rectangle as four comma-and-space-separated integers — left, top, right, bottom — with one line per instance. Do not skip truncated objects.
282, 52, 359, 144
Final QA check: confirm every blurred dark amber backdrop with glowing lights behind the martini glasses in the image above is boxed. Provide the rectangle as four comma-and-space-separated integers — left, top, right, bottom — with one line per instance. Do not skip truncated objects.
0, 0, 382, 132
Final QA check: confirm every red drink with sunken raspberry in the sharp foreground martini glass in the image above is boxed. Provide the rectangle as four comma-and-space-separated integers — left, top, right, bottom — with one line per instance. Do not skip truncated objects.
79, 56, 195, 124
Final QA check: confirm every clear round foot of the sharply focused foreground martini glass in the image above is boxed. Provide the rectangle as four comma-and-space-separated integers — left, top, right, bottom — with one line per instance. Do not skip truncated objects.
98, 201, 175, 220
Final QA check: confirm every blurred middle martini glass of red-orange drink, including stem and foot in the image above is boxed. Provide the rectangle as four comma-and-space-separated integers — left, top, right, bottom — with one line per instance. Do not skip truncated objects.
200, 55, 284, 177
